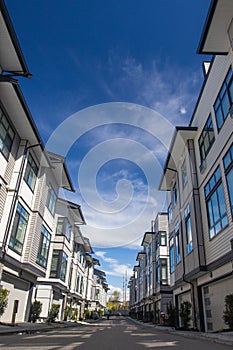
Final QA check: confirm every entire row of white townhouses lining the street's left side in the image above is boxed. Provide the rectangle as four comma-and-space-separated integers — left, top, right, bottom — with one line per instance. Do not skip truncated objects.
0, 0, 108, 322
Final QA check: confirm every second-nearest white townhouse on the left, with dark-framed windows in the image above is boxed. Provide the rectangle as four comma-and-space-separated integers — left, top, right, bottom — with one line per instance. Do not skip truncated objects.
34, 198, 87, 319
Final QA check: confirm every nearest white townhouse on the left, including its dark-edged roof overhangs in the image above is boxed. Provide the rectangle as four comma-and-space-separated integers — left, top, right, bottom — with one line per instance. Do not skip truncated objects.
0, 1, 73, 322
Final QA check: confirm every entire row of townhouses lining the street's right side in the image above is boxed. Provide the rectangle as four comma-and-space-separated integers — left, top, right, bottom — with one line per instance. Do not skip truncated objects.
129, 0, 233, 332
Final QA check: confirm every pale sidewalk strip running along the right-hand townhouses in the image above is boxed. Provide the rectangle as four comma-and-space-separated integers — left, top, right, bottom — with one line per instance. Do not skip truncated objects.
131, 318, 233, 346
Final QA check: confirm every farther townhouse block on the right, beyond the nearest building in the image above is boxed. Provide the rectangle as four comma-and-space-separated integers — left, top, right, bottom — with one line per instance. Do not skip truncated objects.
129, 213, 172, 323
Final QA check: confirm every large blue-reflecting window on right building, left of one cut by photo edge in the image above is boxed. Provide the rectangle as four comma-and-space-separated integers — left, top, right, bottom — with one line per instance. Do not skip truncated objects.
204, 167, 228, 238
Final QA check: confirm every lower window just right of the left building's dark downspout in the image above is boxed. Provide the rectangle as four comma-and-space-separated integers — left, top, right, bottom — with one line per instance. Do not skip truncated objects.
9, 203, 29, 254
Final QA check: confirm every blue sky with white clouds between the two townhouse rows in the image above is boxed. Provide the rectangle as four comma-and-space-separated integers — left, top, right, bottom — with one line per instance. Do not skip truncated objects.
6, 0, 210, 298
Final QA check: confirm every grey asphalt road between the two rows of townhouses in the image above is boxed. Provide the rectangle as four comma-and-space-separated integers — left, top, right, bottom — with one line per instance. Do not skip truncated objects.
0, 317, 231, 350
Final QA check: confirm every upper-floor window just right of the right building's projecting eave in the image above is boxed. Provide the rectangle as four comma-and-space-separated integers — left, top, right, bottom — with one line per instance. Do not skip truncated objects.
198, 114, 215, 163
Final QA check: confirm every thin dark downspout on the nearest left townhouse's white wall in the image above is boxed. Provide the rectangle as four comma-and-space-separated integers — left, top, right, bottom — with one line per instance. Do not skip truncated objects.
0, 142, 41, 276
